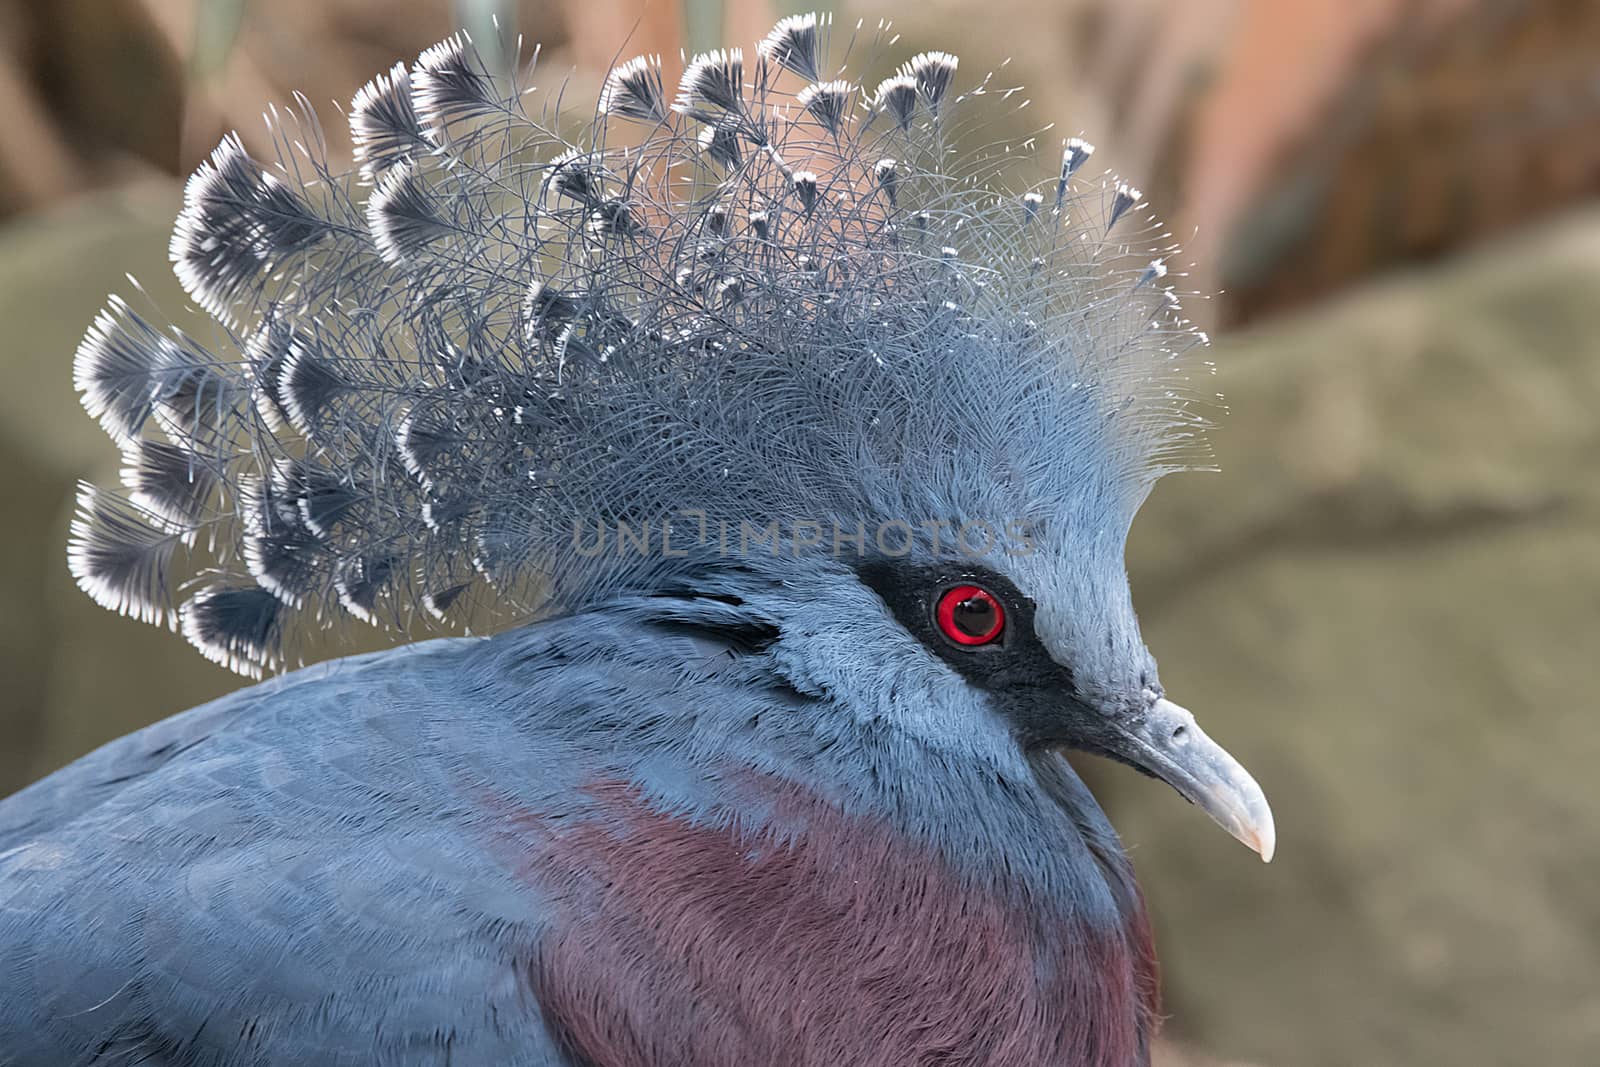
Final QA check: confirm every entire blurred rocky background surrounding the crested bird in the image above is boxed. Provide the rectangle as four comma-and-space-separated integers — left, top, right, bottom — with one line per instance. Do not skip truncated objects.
0, 0, 1600, 1067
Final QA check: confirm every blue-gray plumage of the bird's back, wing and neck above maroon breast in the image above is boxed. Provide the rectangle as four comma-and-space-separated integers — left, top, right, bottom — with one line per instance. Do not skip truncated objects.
0, 579, 1131, 1067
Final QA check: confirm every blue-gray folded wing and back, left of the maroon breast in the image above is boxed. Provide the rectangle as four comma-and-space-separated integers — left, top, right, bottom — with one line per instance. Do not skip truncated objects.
0, 641, 579, 1067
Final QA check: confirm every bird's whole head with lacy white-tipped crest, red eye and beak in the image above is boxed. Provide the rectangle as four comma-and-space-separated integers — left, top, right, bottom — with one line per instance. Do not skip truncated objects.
69, 16, 1274, 857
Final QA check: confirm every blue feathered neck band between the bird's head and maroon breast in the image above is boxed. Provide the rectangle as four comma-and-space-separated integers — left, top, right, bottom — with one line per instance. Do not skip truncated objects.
507, 597, 1144, 928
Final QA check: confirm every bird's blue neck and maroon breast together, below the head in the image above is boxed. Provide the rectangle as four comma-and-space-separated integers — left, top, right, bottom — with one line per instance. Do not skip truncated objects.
480, 608, 1157, 1067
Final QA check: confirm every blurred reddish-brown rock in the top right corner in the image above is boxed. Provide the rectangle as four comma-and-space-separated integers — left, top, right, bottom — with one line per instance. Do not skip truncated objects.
1056, 0, 1600, 323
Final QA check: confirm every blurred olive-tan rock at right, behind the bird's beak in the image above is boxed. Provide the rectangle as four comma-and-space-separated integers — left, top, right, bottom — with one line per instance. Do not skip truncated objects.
1091, 204, 1600, 1067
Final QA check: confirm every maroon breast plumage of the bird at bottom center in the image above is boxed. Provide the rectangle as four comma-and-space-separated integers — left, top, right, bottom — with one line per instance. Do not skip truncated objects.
522, 779, 1158, 1067
